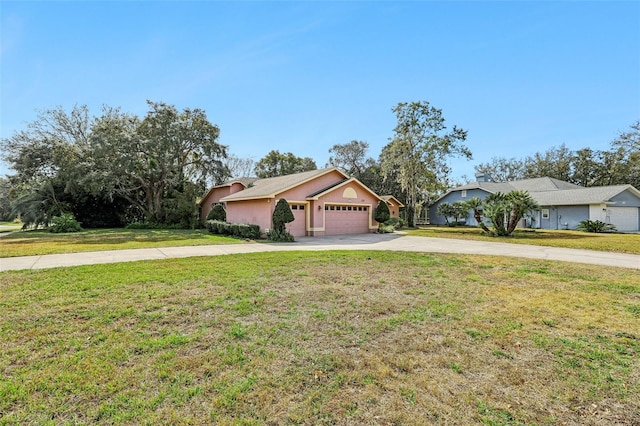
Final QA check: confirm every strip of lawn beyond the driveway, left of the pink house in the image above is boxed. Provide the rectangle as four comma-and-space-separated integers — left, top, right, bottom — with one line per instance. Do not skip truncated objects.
0, 228, 243, 257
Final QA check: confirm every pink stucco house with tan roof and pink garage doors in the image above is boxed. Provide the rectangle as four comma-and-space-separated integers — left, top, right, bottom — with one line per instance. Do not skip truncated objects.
200, 168, 403, 237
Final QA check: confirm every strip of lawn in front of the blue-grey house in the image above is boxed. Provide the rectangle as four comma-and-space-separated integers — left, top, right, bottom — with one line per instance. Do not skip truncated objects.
403, 226, 640, 254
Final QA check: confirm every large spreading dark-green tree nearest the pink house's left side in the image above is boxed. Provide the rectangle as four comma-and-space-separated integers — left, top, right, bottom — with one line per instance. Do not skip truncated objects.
85, 101, 229, 223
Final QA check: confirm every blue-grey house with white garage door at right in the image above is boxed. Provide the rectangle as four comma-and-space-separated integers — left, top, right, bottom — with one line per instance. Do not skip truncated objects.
429, 174, 640, 232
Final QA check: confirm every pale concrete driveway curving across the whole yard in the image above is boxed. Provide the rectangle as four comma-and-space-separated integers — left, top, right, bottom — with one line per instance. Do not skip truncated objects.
0, 234, 640, 271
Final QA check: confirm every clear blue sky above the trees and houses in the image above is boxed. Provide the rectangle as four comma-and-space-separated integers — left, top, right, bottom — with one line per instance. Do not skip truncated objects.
0, 0, 640, 181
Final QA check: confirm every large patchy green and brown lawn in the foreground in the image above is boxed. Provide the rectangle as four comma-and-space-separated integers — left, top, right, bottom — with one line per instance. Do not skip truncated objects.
0, 251, 640, 425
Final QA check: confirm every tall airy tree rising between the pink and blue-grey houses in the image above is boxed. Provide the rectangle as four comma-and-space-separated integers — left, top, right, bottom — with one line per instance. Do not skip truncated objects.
380, 101, 471, 226
